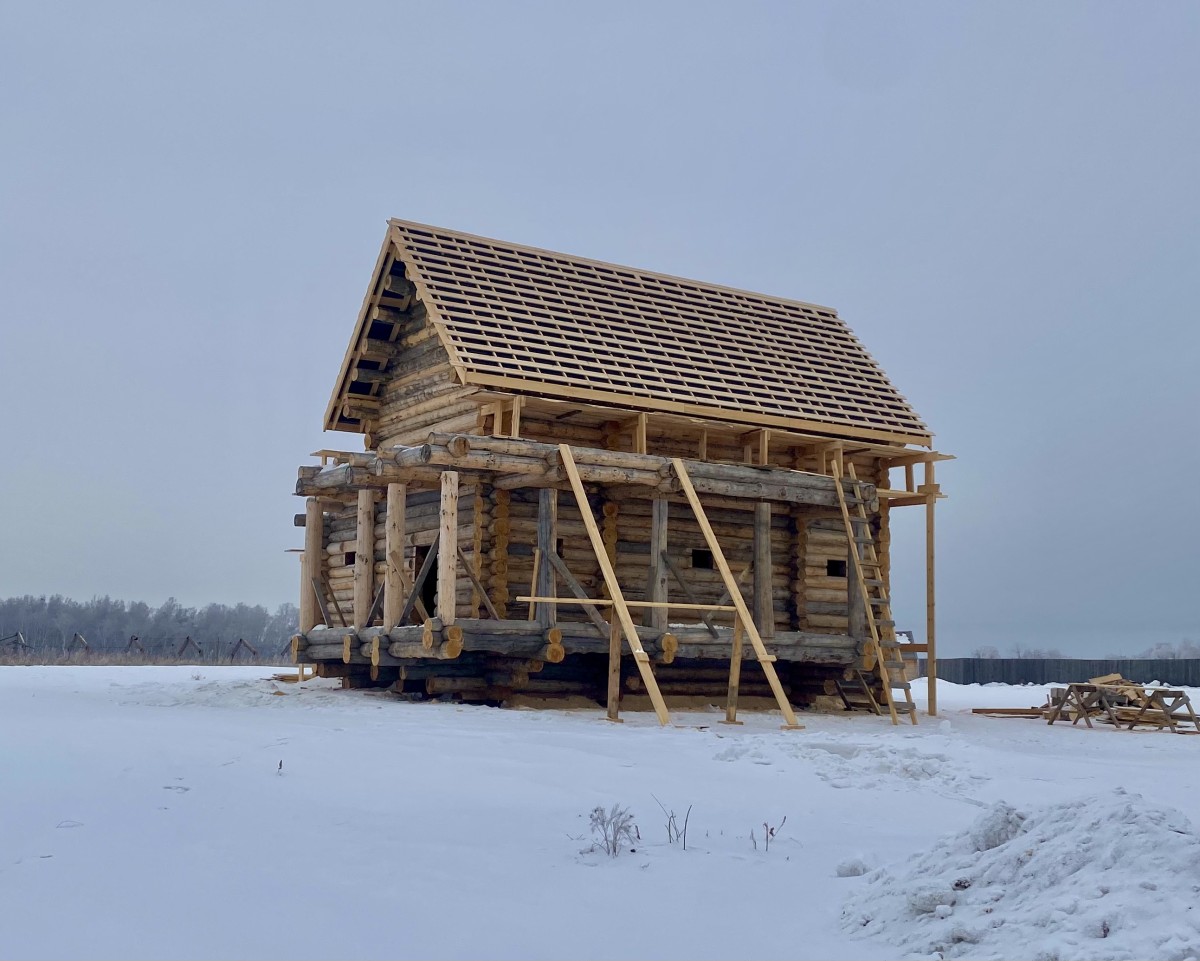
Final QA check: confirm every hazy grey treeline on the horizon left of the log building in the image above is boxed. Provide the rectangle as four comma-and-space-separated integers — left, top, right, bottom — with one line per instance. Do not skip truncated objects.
0, 594, 299, 657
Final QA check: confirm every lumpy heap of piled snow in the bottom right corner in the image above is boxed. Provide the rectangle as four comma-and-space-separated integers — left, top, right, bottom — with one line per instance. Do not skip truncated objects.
842, 788, 1200, 961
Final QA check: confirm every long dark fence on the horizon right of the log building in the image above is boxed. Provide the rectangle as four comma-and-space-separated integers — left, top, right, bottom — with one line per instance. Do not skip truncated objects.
920, 657, 1200, 687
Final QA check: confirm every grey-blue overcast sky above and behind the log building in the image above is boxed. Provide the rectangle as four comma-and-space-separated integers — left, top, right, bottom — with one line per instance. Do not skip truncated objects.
0, 0, 1200, 656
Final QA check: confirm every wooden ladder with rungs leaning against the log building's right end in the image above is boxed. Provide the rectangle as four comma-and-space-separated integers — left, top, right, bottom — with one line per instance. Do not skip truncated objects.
832, 457, 917, 725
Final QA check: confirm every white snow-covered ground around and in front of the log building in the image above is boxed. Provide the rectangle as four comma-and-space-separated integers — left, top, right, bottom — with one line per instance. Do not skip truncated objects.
0, 667, 1200, 959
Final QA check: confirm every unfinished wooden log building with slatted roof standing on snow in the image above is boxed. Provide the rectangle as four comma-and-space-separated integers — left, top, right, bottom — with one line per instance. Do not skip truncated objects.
293, 221, 948, 726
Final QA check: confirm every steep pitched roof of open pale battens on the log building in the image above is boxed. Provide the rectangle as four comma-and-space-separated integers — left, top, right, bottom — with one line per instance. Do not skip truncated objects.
326, 221, 930, 444
